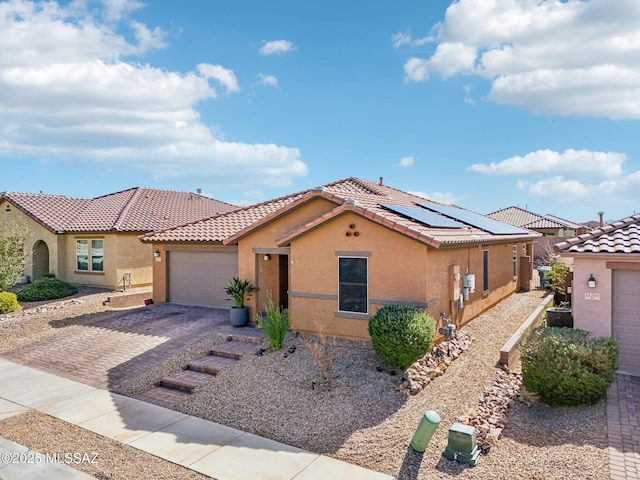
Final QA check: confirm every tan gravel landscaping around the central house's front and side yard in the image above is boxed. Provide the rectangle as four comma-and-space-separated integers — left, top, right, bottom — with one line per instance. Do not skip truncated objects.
0, 291, 609, 480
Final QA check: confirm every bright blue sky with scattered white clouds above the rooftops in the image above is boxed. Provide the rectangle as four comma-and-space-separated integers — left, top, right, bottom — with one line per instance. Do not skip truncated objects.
0, 0, 640, 222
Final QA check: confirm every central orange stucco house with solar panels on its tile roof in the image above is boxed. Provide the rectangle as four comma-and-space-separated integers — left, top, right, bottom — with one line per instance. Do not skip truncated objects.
141, 178, 539, 339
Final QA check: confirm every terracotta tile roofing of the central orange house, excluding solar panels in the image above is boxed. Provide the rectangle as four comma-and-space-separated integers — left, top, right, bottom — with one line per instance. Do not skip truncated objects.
141, 178, 540, 247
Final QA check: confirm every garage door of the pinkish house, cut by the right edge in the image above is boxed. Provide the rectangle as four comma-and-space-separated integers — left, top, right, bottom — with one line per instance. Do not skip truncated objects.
613, 270, 640, 375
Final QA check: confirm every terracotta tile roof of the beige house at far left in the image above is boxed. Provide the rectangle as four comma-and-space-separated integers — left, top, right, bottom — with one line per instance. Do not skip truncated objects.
0, 187, 238, 232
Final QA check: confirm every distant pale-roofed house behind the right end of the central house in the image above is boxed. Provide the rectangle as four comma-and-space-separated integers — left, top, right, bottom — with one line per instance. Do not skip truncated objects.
487, 207, 587, 237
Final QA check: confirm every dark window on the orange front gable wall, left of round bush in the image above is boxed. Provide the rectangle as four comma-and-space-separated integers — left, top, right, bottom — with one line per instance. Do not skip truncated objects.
338, 257, 369, 313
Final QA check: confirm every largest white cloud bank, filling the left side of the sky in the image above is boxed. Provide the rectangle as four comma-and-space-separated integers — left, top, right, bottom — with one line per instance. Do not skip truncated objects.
0, 0, 307, 186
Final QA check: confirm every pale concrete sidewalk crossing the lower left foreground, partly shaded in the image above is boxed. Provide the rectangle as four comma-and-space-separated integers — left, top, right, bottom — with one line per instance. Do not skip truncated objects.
0, 359, 392, 480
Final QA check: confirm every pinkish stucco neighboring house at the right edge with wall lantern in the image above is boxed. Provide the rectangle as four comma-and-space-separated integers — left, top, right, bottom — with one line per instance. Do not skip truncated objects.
555, 215, 640, 375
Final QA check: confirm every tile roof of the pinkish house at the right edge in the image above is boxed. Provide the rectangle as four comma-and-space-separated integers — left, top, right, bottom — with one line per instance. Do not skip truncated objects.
554, 214, 640, 253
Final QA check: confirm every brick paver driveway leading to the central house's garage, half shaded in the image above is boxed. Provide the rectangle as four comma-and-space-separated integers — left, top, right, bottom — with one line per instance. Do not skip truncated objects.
3, 303, 229, 390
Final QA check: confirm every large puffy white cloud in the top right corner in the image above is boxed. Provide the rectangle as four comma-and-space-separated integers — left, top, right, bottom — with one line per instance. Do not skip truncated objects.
404, 0, 640, 119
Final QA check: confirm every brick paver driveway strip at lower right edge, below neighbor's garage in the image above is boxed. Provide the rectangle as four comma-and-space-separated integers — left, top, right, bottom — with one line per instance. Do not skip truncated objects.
607, 374, 640, 480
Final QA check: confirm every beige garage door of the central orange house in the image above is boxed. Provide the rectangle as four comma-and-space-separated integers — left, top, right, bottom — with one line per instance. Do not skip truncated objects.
169, 248, 238, 308
